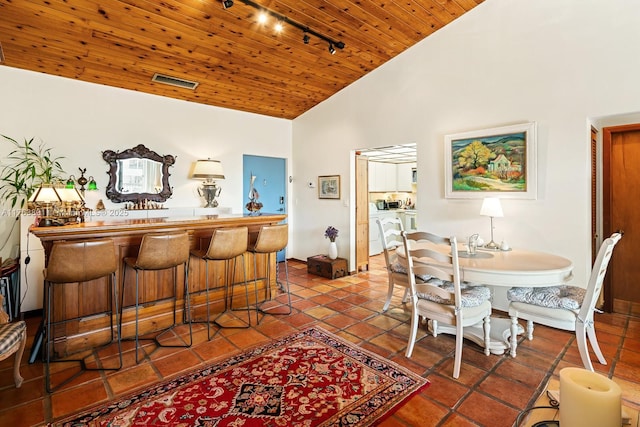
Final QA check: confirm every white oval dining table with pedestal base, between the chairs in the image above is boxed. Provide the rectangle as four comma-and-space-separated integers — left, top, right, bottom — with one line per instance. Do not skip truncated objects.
396, 242, 573, 354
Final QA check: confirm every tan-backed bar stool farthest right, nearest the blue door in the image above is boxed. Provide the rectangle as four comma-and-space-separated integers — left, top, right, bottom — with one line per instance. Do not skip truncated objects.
248, 224, 291, 322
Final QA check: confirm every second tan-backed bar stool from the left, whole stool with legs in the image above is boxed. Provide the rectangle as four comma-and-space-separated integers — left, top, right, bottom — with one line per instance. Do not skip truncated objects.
120, 231, 193, 363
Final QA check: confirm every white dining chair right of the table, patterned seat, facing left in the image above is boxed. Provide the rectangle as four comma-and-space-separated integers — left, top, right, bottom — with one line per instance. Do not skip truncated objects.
507, 233, 622, 371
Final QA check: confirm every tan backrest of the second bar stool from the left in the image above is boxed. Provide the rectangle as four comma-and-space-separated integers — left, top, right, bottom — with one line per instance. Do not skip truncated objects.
134, 231, 189, 270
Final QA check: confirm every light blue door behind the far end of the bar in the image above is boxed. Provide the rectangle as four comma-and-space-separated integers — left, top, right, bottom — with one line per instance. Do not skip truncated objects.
242, 154, 287, 262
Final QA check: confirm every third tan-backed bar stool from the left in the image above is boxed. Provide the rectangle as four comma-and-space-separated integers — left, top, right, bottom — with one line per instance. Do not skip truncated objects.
190, 227, 251, 340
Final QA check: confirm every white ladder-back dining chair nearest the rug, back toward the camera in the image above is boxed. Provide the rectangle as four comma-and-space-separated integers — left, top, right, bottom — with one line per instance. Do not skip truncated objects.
398, 231, 491, 378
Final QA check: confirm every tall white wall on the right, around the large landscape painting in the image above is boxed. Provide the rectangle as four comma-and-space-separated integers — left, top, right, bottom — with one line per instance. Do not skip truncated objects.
291, 0, 640, 283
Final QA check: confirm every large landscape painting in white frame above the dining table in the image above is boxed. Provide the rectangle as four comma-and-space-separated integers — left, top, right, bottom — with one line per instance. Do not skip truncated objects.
444, 122, 537, 199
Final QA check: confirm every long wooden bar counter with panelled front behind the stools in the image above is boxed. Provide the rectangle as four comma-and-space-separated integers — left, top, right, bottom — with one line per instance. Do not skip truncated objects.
31, 214, 286, 357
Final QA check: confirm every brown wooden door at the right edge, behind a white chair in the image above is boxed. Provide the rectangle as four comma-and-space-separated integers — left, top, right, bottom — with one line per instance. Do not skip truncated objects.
602, 124, 640, 315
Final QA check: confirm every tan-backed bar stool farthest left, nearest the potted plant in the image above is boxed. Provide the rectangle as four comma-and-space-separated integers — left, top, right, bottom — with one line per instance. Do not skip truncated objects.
44, 239, 122, 392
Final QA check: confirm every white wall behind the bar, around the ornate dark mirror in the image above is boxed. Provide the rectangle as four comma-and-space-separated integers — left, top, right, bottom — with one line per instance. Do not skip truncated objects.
0, 67, 292, 257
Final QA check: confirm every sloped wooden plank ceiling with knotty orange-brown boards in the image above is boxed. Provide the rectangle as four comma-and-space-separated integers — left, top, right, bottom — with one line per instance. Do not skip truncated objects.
0, 0, 484, 119
